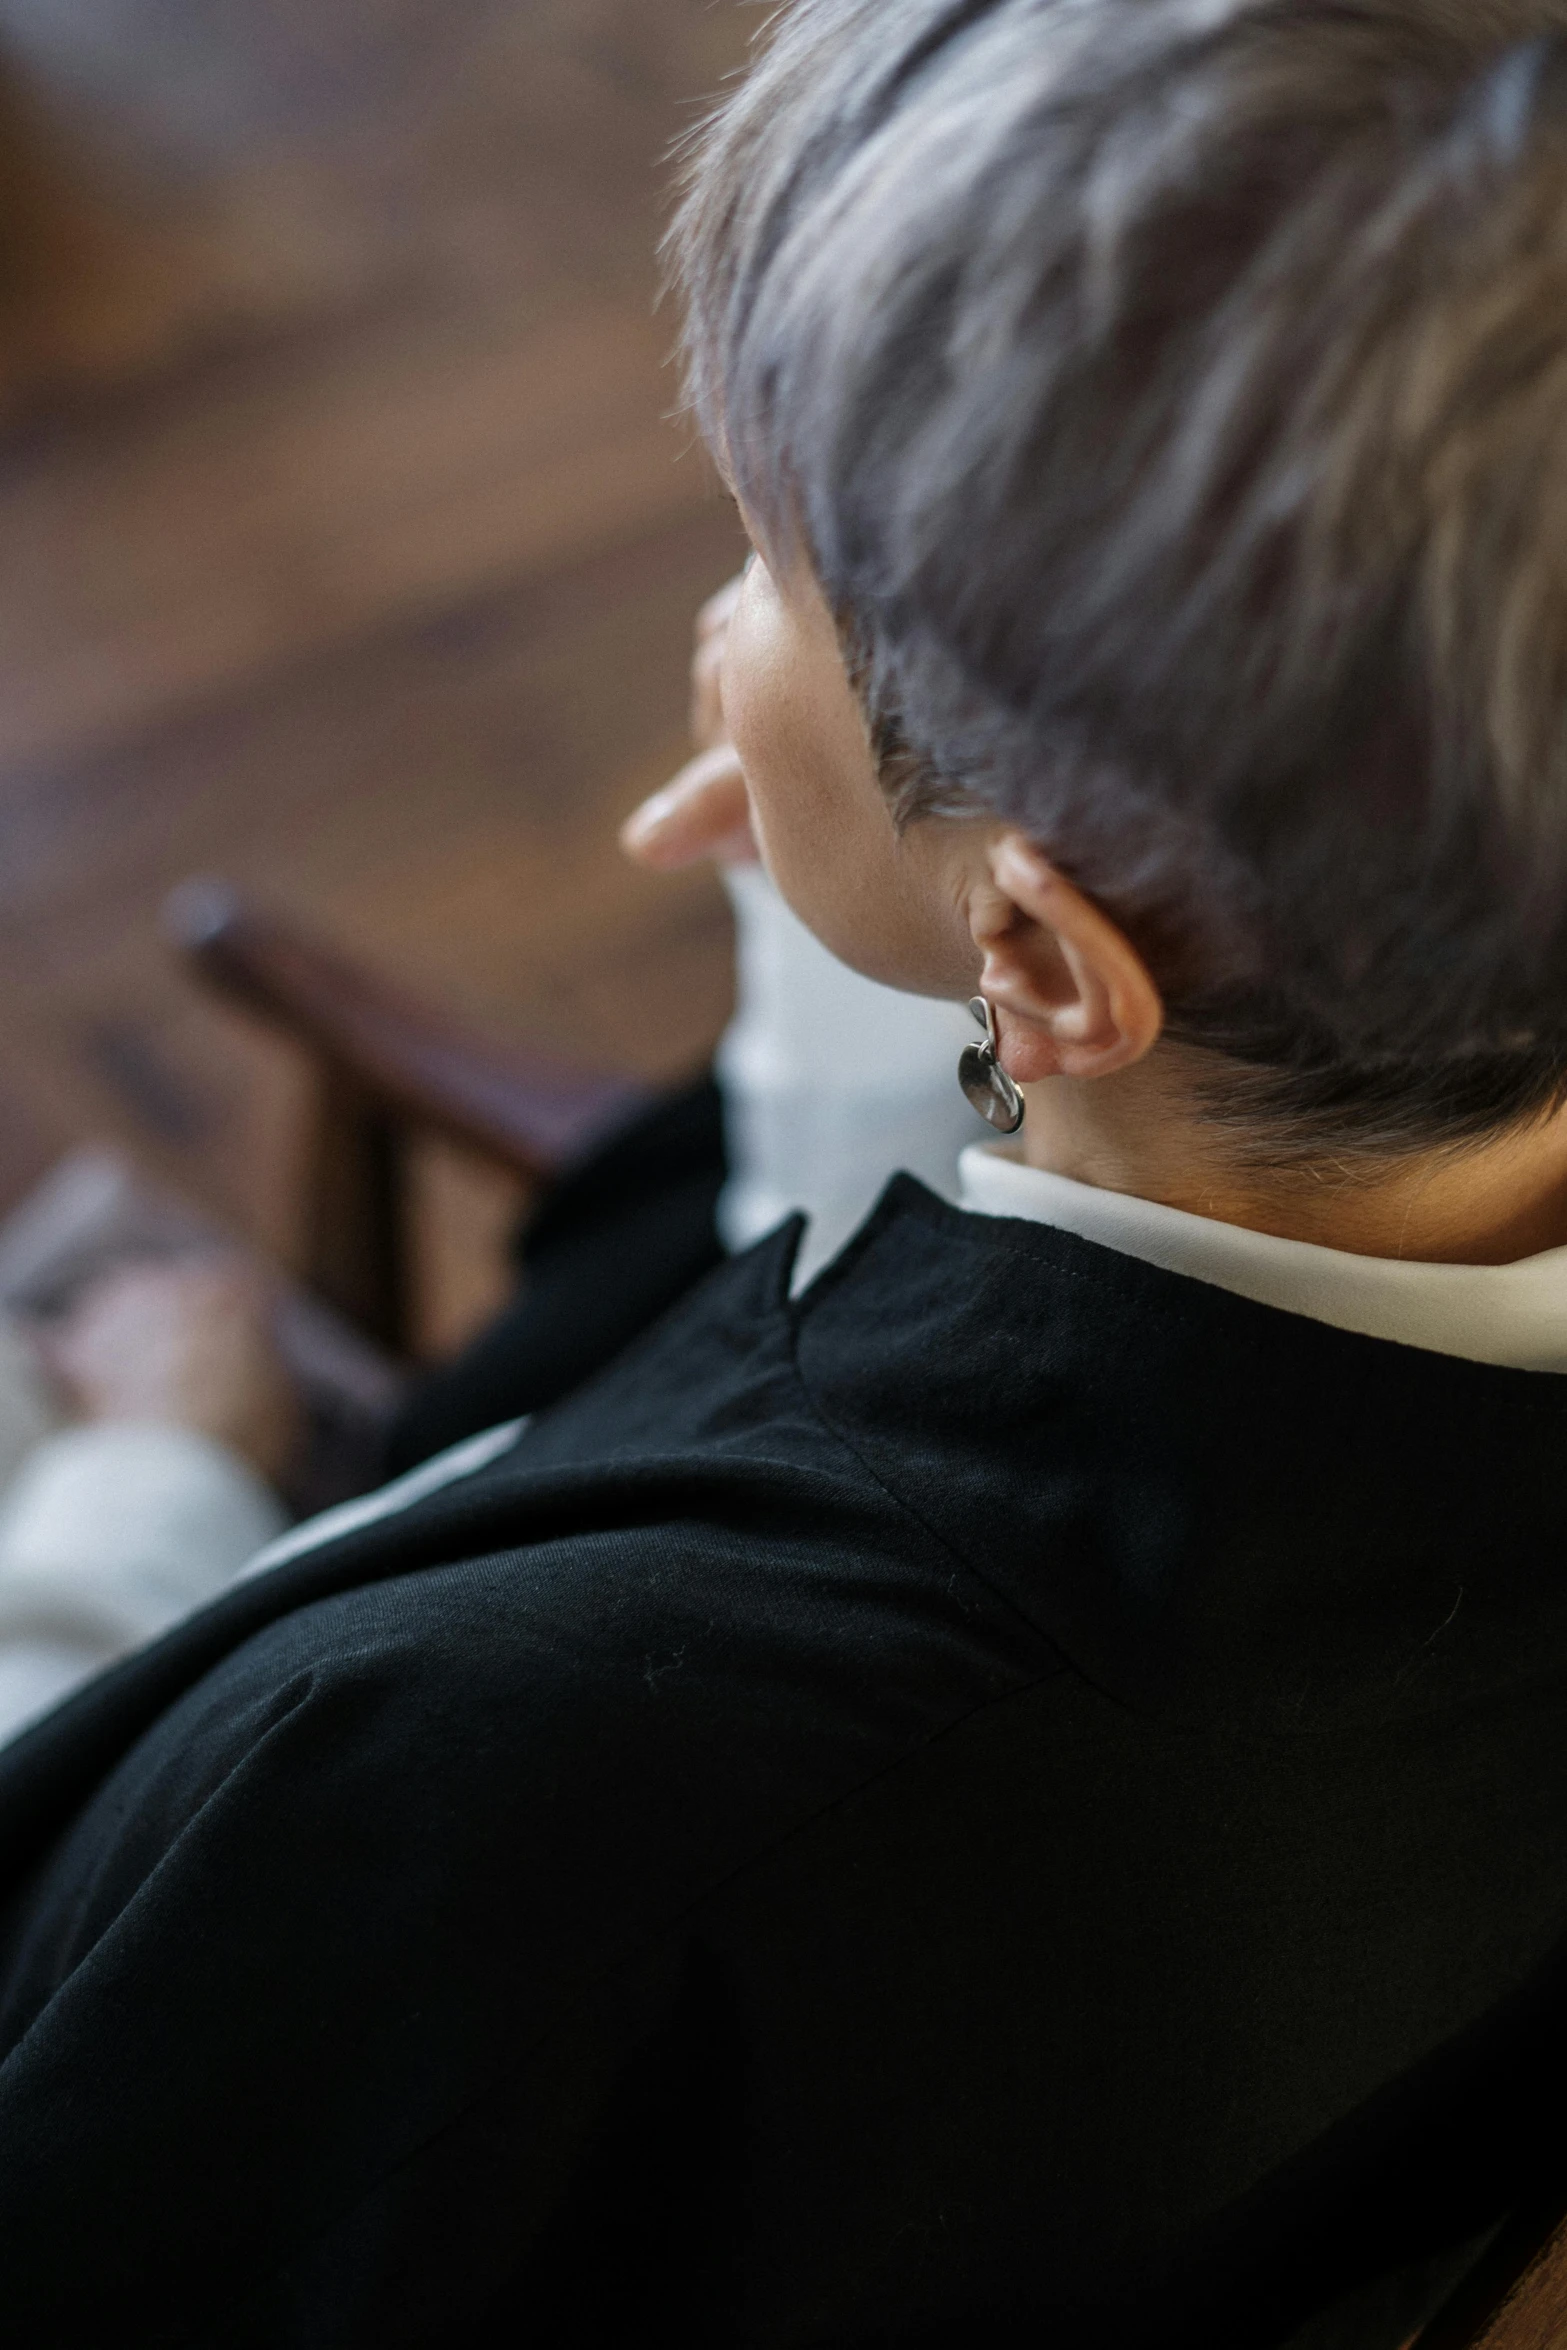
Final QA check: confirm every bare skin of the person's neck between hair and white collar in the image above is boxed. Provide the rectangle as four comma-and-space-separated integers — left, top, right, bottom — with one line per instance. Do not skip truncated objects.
1022, 1043, 1567, 1264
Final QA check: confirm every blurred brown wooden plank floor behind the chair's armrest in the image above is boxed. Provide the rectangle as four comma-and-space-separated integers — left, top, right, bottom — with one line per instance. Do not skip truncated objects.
0, 0, 747, 1353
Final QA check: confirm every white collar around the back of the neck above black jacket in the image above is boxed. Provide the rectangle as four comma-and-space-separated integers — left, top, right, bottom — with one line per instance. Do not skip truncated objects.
959, 1142, 1567, 1370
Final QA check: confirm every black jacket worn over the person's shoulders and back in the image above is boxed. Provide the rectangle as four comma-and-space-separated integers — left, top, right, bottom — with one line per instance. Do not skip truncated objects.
0, 1177, 1567, 2350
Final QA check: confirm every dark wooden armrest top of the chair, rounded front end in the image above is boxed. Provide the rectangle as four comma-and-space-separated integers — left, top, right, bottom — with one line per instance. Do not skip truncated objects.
164, 881, 651, 1180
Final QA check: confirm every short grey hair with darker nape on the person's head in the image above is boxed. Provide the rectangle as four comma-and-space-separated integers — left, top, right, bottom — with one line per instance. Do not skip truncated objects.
672, 0, 1567, 1156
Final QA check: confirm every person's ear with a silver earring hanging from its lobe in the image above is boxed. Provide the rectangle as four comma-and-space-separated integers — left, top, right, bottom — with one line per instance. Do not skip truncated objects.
968, 832, 1165, 1086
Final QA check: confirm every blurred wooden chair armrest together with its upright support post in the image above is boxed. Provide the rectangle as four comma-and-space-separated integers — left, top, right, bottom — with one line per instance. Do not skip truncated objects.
164, 881, 651, 1354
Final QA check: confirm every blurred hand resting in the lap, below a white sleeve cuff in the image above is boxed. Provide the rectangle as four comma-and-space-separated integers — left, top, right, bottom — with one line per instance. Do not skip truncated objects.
42, 1260, 301, 1481
